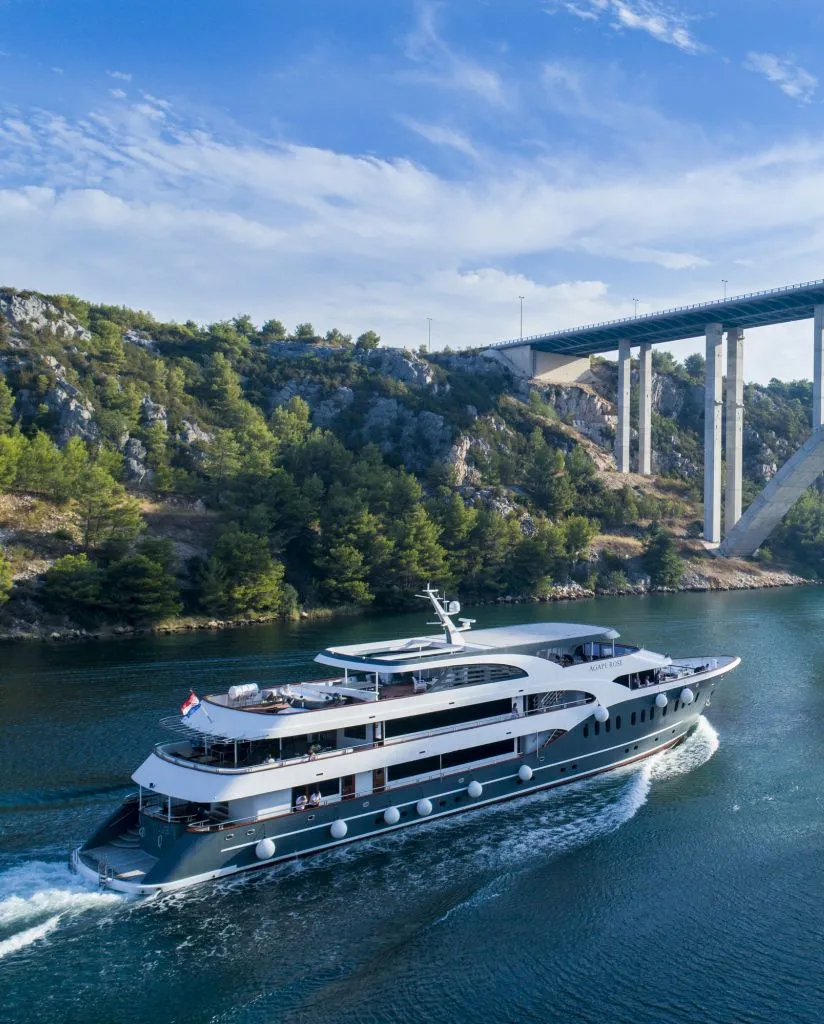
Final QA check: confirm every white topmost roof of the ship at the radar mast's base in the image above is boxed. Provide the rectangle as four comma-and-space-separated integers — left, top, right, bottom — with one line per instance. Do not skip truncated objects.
315, 623, 619, 675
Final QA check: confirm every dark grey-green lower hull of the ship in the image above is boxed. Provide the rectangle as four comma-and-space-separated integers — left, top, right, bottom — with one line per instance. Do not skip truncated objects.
72, 681, 714, 895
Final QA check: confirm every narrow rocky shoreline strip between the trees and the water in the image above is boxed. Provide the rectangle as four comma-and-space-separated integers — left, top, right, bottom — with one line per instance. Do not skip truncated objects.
0, 562, 810, 645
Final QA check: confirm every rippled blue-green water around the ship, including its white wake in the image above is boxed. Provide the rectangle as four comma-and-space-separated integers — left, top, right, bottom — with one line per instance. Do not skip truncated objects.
0, 588, 824, 1024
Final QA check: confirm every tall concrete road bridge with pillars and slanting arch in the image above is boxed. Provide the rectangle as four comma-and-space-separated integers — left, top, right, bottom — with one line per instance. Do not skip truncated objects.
488, 281, 824, 556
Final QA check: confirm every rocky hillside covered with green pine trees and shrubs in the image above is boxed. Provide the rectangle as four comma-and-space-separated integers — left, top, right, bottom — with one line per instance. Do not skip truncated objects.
0, 289, 824, 628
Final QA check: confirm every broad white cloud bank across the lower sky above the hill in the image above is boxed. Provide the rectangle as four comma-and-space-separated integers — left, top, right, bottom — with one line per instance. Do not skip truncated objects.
0, 93, 824, 377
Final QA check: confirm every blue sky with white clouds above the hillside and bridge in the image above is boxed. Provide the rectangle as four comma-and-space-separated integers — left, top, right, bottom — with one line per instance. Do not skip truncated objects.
0, 0, 824, 381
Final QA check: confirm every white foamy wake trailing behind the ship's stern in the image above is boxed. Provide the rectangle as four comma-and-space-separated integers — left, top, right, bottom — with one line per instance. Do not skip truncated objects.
0, 860, 122, 959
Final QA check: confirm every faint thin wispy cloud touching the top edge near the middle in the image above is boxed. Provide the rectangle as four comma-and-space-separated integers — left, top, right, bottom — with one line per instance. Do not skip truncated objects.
404, 5, 509, 106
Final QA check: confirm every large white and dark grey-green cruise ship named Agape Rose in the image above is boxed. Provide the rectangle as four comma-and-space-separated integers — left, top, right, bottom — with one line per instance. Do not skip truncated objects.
71, 588, 740, 895
